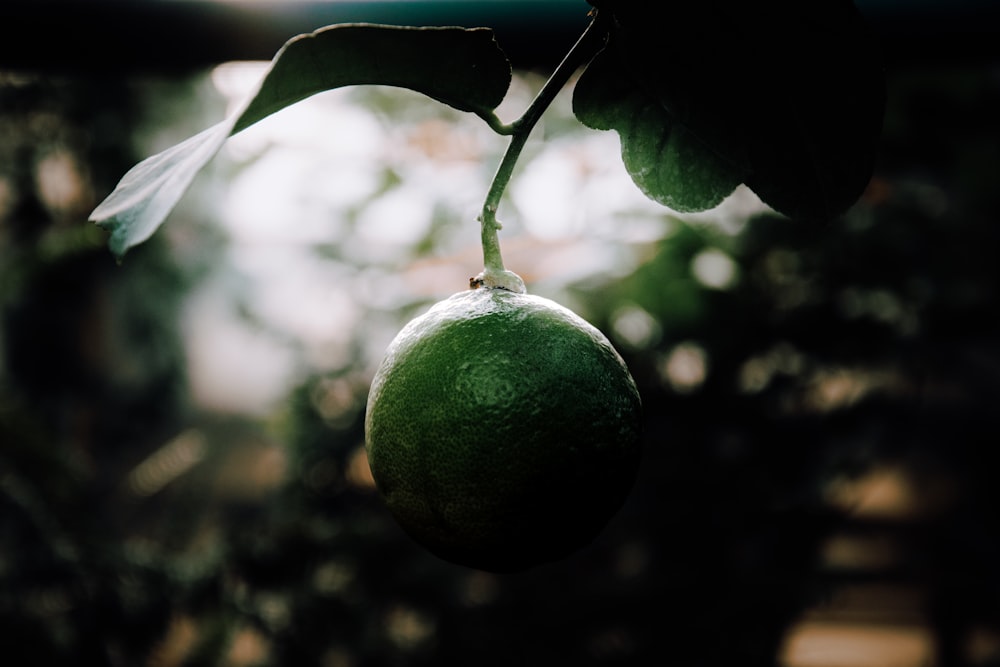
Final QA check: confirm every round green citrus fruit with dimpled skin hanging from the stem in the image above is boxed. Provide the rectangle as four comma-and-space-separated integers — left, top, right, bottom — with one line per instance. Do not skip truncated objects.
365, 288, 641, 572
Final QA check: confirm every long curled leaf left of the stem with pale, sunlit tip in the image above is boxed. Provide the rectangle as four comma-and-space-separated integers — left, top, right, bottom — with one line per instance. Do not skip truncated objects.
90, 24, 511, 258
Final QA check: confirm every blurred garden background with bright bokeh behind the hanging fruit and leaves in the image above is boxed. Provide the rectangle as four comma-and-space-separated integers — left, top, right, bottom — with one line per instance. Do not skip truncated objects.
0, 2, 1000, 667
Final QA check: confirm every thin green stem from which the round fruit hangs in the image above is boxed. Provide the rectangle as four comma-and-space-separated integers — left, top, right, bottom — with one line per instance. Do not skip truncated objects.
472, 10, 607, 292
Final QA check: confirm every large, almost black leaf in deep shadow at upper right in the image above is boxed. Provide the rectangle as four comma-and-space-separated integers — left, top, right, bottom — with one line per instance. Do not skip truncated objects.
580, 0, 885, 218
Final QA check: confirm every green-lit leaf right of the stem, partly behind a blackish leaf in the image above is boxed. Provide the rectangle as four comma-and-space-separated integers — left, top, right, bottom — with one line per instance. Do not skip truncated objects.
573, 45, 742, 211
